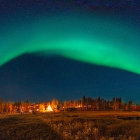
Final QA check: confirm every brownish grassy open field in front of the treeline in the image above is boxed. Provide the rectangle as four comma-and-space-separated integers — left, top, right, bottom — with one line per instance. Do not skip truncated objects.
0, 111, 140, 140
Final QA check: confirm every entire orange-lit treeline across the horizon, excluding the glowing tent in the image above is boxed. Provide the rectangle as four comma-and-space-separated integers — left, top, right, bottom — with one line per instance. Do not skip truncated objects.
0, 96, 140, 113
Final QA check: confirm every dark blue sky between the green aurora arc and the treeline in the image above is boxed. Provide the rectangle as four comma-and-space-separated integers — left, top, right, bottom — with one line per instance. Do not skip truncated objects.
0, 54, 140, 102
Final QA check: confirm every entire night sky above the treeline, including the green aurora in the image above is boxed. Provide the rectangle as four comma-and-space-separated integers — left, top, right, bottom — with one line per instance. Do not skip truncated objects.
0, 0, 140, 103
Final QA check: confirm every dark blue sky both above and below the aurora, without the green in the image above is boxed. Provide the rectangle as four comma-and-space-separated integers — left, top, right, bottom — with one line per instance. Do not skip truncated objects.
0, 0, 140, 102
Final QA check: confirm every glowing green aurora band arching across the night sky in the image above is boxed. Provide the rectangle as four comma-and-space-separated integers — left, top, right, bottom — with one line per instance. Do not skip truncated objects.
0, 15, 140, 74
